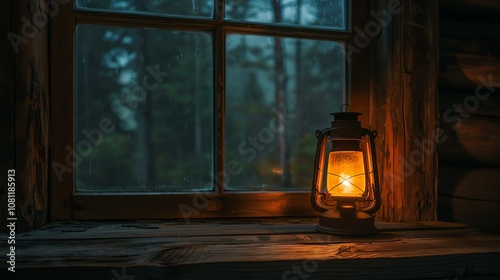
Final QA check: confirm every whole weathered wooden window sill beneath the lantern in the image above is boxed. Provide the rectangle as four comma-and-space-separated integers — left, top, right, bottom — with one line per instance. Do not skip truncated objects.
0, 218, 500, 280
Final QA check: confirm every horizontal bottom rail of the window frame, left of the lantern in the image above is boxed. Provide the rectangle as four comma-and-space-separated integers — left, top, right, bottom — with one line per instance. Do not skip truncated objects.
73, 192, 319, 221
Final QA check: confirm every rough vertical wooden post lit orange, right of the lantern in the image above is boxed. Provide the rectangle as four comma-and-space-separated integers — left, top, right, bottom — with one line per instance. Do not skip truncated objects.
371, 0, 439, 222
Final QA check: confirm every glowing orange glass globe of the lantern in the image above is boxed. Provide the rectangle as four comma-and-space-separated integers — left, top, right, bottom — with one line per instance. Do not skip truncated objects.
326, 151, 365, 197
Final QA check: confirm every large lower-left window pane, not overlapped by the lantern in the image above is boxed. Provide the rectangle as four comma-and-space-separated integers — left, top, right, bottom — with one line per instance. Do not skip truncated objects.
75, 24, 213, 192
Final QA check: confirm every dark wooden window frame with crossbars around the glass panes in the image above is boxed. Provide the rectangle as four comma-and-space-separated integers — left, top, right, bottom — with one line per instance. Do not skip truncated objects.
49, 0, 370, 220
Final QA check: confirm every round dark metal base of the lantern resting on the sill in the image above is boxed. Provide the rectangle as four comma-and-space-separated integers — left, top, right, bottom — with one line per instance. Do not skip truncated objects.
316, 209, 378, 236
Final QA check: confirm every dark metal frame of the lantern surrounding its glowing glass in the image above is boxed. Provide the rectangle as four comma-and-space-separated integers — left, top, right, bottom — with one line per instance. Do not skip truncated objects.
311, 112, 380, 235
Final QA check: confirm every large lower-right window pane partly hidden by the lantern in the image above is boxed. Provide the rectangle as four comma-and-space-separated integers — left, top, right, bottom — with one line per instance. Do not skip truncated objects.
225, 34, 345, 191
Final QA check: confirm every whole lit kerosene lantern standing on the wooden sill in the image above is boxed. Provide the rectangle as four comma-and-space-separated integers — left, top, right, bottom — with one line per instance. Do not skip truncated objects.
311, 112, 380, 235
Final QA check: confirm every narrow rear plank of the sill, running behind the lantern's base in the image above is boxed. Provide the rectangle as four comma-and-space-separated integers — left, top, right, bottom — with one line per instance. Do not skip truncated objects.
9, 219, 464, 241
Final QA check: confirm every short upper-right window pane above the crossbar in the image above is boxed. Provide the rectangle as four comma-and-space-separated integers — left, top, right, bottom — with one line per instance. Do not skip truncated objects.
225, 0, 347, 30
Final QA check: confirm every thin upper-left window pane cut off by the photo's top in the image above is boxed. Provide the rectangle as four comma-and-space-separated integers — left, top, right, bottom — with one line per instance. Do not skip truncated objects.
76, 0, 214, 18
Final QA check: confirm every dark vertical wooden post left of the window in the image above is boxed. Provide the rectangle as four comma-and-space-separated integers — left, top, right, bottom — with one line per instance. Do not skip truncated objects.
0, 0, 50, 231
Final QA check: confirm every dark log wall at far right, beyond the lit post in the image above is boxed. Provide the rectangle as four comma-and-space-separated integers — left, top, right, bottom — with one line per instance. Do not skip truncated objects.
438, 0, 500, 231
